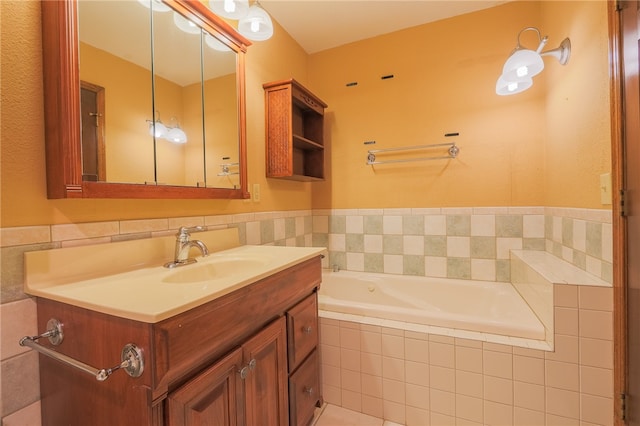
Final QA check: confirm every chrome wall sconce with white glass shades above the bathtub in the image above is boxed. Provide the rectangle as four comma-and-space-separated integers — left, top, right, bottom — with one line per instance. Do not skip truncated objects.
496, 27, 571, 95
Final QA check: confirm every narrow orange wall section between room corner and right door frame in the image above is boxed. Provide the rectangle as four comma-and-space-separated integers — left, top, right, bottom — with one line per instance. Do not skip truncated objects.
543, 1, 611, 209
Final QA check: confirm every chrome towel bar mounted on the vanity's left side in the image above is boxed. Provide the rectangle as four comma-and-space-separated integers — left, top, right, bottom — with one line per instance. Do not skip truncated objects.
20, 318, 144, 382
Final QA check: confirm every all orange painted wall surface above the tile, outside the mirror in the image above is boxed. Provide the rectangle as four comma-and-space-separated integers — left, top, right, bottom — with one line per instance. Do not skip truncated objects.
0, 1, 610, 227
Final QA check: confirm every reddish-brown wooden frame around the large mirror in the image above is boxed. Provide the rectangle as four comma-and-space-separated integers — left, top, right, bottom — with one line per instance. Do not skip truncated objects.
40, 0, 251, 199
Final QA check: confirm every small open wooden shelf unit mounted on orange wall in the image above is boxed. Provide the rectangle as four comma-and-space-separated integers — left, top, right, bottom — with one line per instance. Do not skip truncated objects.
262, 79, 327, 181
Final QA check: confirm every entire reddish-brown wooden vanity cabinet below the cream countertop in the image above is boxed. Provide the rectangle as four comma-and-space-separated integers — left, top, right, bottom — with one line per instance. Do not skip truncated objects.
37, 257, 321, 426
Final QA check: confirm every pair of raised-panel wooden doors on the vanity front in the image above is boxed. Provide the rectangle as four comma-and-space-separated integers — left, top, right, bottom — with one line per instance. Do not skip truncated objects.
166, 317, 288, 426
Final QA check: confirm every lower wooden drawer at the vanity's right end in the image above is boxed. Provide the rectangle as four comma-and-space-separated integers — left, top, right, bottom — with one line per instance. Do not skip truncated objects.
289, 351, 321, 426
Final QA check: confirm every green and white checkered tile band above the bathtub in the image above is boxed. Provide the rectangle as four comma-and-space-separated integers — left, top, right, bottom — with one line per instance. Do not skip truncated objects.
313, 207, 613, 283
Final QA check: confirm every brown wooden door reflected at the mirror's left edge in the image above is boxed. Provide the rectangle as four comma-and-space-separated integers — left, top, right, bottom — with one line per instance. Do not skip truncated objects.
80, 81, 106, 182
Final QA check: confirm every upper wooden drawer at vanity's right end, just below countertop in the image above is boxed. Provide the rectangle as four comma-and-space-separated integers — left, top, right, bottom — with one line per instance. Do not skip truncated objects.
287, 293, 318, 372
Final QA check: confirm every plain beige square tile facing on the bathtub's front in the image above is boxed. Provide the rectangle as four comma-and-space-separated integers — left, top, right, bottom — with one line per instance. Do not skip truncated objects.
320, 285, 613, 426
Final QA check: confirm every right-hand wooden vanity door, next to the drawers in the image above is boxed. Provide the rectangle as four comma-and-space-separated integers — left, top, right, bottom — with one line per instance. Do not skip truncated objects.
242, 317, 289, 426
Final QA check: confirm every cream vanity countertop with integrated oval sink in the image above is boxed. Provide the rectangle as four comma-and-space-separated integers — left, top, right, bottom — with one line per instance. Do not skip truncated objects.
25, 245, 326, 323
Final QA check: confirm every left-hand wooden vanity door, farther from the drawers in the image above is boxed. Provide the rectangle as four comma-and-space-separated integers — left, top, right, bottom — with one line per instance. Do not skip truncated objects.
166, 349, 243, 426
